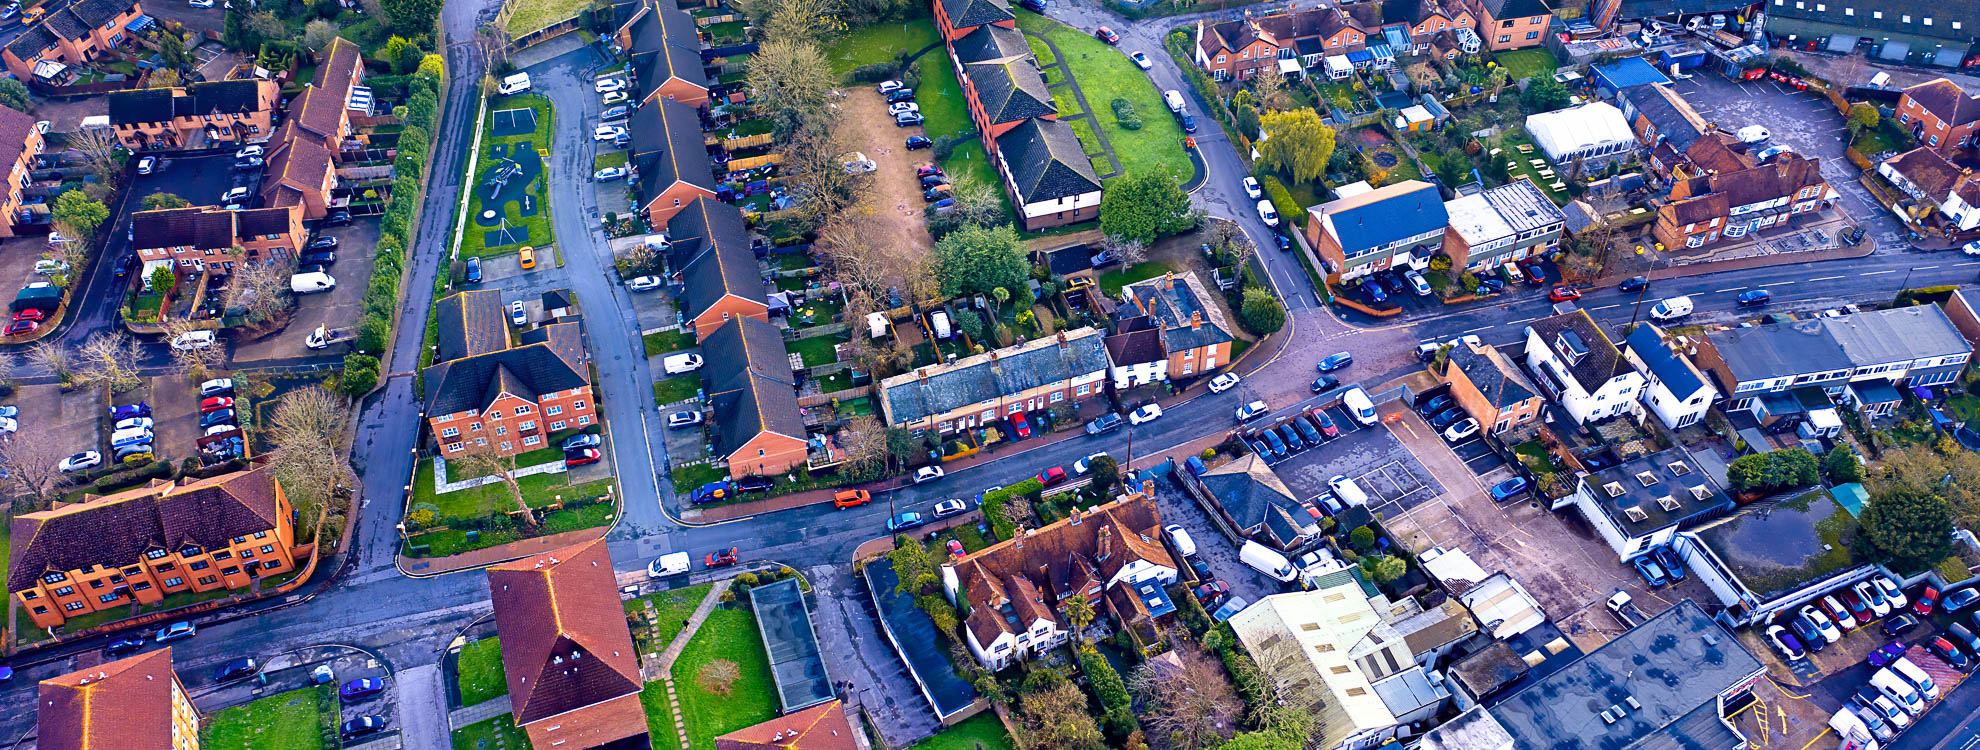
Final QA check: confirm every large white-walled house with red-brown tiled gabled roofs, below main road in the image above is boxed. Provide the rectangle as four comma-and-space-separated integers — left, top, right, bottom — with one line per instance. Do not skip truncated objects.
942, 493, 1176, 671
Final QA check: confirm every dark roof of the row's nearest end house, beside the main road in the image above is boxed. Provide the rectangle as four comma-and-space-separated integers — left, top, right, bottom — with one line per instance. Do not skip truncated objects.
701, 317, 806, 457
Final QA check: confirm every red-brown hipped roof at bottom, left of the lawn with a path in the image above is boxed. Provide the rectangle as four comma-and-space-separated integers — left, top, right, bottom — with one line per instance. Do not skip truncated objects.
489, 538, 642, 724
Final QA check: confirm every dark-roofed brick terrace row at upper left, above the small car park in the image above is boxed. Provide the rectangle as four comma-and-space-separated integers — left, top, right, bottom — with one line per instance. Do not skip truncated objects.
109, 79, 281, 150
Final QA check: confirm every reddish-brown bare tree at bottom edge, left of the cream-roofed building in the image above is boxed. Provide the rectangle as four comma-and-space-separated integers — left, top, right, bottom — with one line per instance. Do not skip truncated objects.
1129, 645, 1243, 750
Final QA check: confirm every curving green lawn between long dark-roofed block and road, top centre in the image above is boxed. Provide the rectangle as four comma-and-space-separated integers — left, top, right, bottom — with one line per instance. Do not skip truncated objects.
1018, 14, 1210, 182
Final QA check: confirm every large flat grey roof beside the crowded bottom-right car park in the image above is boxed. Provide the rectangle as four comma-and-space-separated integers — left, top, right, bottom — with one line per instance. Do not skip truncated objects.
1491, 600, 1764, 750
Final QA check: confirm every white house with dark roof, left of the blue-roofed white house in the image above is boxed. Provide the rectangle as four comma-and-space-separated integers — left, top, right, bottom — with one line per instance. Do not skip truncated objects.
1527, 311, 1643, 423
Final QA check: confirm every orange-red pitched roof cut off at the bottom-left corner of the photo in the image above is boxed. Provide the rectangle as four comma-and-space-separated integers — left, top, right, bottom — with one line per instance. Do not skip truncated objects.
34, 647, 190, 750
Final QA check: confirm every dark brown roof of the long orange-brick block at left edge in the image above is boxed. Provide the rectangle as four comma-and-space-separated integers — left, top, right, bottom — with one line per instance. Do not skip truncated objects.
8, 469, 281, 592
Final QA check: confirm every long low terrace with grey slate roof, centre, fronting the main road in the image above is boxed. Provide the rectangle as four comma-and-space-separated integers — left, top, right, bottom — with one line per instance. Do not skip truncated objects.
879, 328, 1111, 433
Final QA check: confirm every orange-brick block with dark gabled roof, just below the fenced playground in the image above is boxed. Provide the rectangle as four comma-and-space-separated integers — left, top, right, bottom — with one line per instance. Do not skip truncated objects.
420, 289, 598, 459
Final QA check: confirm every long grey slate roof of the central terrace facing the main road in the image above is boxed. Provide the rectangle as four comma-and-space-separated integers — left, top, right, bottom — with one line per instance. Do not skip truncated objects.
881, 328, 1109, 423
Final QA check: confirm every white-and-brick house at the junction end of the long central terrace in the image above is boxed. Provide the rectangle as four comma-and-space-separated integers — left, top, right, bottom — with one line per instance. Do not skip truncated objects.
1115, 271, 1236, 380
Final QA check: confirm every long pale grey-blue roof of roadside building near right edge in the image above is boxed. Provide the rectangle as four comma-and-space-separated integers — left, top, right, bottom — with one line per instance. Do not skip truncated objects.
1705, 305, 1972, 384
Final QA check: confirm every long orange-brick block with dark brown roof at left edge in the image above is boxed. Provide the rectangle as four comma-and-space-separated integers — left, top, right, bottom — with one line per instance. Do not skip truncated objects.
8, 469, 302, 627
